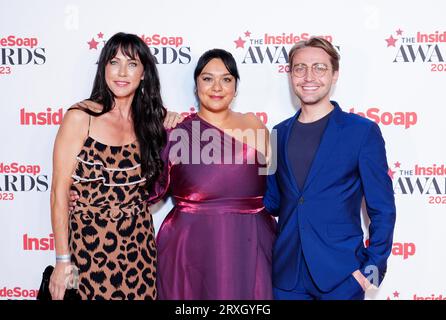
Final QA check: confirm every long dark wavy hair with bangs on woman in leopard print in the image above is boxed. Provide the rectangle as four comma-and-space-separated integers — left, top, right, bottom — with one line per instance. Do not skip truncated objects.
74, 32, 167, 188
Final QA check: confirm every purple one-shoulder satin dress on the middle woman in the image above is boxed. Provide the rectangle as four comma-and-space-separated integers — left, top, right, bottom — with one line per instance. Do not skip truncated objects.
151, 114, 276, 300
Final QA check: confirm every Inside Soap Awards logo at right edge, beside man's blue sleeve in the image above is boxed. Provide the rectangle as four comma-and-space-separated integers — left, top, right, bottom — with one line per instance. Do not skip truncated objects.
388, 161, 446, 206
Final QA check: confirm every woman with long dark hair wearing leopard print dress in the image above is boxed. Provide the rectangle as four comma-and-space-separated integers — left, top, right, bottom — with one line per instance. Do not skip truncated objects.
50, 33, 172, 299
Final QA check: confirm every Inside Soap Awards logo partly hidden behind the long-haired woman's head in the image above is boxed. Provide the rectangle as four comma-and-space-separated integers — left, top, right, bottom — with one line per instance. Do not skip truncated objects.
86, 32, 192, 65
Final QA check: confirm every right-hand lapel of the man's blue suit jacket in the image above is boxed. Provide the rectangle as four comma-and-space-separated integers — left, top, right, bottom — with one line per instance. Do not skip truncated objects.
304, 101, 342, 191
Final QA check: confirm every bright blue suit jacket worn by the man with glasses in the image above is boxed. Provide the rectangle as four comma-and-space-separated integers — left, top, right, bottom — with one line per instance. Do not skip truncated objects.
264, 101, 396, 291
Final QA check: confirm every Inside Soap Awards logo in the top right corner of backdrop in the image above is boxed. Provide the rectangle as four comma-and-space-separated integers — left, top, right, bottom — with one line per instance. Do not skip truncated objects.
384, 28, 446, 72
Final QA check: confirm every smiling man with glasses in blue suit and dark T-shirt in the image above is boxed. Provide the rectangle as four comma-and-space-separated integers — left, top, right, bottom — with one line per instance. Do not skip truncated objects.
264, 37, 396, 300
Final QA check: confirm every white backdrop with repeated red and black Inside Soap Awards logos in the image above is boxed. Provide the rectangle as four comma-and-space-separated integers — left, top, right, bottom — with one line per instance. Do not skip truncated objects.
0, 0, 446, 300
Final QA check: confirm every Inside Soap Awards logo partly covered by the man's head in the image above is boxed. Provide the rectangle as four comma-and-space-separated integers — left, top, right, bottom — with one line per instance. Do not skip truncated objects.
233, 30, 339, 73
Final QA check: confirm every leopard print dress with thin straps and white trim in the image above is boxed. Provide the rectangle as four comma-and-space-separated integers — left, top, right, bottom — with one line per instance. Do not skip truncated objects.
69, 136, 157, 300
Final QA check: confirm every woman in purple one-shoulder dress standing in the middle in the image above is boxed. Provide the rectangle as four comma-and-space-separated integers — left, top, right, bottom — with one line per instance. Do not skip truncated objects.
150, 49, 276, 300
